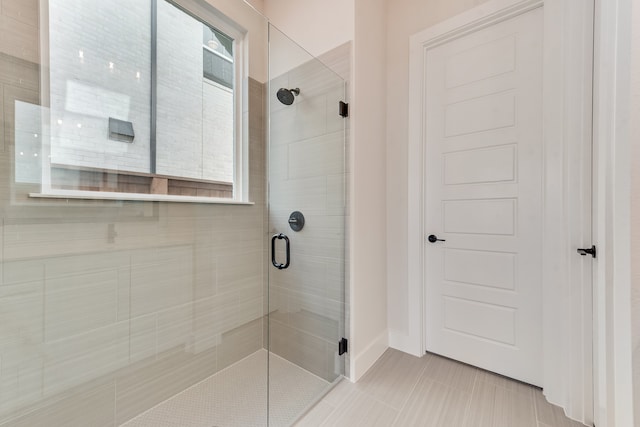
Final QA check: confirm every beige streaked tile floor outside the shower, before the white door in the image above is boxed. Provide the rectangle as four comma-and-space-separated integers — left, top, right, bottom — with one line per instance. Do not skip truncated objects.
296, 349, 582, 427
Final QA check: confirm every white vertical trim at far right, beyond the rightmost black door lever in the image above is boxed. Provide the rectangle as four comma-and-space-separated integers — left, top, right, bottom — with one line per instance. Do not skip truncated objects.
594, 0, 638, 427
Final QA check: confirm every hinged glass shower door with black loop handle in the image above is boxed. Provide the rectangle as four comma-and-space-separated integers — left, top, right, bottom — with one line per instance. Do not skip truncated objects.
268, 26, 345, 426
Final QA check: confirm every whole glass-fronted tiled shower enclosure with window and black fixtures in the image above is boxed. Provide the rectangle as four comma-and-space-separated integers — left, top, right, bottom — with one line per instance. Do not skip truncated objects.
0, 0, 347, 427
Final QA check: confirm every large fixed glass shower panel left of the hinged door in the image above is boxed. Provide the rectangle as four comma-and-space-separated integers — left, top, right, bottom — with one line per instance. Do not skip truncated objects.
0, 0, 268, 427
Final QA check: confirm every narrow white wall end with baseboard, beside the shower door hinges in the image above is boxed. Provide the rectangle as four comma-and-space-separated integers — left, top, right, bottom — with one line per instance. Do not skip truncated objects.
351, 0, 388, 380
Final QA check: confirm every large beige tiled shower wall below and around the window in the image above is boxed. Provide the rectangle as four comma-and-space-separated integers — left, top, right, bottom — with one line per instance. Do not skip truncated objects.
0, 4, 266, 427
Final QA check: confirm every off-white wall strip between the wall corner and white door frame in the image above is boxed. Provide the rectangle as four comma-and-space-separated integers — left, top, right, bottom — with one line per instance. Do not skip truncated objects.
386, 0, 492, 341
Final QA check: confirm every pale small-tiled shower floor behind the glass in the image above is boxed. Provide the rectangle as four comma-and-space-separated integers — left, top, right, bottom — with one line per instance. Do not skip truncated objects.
121, 350, 331, 427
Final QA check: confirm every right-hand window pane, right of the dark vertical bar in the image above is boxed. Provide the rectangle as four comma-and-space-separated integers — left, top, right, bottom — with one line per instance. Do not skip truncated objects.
155, 0, 236, 187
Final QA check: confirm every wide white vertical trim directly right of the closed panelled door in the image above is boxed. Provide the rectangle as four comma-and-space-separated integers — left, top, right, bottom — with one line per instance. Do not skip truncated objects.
543, 0, 599, 424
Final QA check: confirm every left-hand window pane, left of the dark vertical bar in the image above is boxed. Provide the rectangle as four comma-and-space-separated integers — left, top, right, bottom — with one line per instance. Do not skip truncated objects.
47, 0, 151, 177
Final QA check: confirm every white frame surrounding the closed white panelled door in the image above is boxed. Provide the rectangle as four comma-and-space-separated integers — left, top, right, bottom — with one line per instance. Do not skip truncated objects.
404, 0, 596, 425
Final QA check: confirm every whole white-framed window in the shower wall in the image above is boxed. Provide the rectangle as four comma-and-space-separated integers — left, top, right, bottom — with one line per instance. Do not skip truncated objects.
31, 0, 246, 201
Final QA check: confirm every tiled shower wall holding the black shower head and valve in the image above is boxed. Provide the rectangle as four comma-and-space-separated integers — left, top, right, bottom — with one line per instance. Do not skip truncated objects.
268, 42, 349, 381
